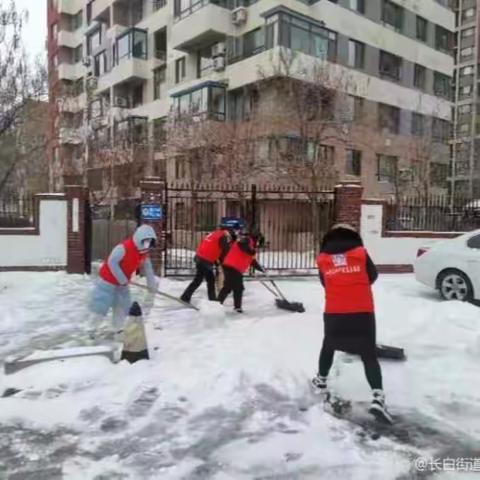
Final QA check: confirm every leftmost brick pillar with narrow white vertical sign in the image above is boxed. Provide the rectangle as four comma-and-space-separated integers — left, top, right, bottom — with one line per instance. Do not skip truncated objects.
65, 185, 90, 274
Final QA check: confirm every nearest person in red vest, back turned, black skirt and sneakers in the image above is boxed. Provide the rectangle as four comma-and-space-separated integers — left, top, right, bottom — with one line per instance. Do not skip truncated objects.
312, 224, 391, 422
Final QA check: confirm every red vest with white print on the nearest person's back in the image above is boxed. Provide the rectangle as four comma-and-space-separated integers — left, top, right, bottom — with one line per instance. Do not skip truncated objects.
317, 247, 374, 313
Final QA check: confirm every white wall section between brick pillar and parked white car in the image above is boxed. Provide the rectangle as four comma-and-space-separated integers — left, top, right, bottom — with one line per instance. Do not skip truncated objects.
361, 205, 446, 265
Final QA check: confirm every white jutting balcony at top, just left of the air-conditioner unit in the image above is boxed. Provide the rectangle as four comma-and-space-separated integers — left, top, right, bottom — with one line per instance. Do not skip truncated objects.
172, 0, 234, 52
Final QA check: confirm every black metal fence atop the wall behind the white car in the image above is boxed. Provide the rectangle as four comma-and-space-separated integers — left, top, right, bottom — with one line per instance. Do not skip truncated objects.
385, 195, 480, 232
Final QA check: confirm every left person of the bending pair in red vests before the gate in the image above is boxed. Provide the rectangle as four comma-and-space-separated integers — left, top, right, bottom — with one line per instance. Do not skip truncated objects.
180, 225, 236, 303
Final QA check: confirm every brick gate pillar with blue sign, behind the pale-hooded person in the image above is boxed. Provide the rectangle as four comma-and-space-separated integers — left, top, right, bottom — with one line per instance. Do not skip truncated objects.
140, 177, 165, 275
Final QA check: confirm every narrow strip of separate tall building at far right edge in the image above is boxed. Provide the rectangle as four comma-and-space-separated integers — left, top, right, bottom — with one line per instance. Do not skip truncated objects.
450, 0, 480, 198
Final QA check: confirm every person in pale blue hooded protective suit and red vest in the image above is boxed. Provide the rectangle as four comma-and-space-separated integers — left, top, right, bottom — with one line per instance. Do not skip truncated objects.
90, 225, 158, 334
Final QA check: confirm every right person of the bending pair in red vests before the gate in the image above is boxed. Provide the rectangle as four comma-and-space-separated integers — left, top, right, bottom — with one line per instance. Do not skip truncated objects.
218, 230, 265, 313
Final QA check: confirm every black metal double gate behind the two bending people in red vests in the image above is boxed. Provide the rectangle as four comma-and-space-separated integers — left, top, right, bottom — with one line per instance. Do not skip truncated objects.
164, 185, 334, 275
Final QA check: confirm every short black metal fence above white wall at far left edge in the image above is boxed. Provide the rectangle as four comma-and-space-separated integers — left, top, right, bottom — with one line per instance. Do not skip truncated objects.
0, 191, 37, 228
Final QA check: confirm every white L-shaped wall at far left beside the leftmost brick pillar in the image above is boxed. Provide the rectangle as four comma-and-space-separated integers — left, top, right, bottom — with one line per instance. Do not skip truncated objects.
0, 198, 67, 267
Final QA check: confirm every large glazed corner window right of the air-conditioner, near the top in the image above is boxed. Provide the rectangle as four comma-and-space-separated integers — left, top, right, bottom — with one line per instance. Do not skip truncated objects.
274, 13, 337, 61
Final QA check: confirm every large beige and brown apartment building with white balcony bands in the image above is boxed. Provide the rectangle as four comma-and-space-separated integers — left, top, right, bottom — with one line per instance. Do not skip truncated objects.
48, 0, 454, 196
